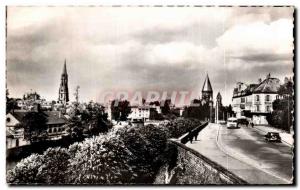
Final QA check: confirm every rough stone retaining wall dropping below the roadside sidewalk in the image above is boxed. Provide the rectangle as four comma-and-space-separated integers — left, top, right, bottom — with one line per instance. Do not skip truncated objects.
154, 139, 247, 185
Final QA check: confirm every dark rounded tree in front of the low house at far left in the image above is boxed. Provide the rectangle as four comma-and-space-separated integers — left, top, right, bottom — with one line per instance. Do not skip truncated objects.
21, 111, 48, 142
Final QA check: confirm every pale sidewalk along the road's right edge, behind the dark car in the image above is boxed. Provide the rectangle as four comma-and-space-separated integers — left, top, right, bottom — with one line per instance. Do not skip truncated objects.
254, 125, 294, 146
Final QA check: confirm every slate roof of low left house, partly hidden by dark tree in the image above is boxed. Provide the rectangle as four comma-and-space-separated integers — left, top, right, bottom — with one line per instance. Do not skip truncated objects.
11, 110, 67, 125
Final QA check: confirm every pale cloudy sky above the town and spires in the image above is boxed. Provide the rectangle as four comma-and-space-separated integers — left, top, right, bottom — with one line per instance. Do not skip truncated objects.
7, 7, 293, 104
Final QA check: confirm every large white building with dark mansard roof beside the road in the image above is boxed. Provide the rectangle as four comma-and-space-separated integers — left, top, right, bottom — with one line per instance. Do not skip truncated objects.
232, 74, 281, 125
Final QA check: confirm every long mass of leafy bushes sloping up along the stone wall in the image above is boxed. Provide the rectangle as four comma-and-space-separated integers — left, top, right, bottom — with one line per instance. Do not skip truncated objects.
7, 118, 200, 184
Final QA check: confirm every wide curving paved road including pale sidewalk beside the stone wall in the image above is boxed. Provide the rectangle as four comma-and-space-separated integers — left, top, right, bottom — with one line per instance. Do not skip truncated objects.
186, 124, 293, 184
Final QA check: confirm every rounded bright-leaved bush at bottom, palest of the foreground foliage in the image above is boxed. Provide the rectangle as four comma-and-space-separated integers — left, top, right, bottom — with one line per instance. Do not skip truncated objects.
68, 135, 135, 184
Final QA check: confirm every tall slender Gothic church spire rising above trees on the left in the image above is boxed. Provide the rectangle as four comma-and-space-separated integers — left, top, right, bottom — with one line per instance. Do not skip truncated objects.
58, 60, 69, 104
